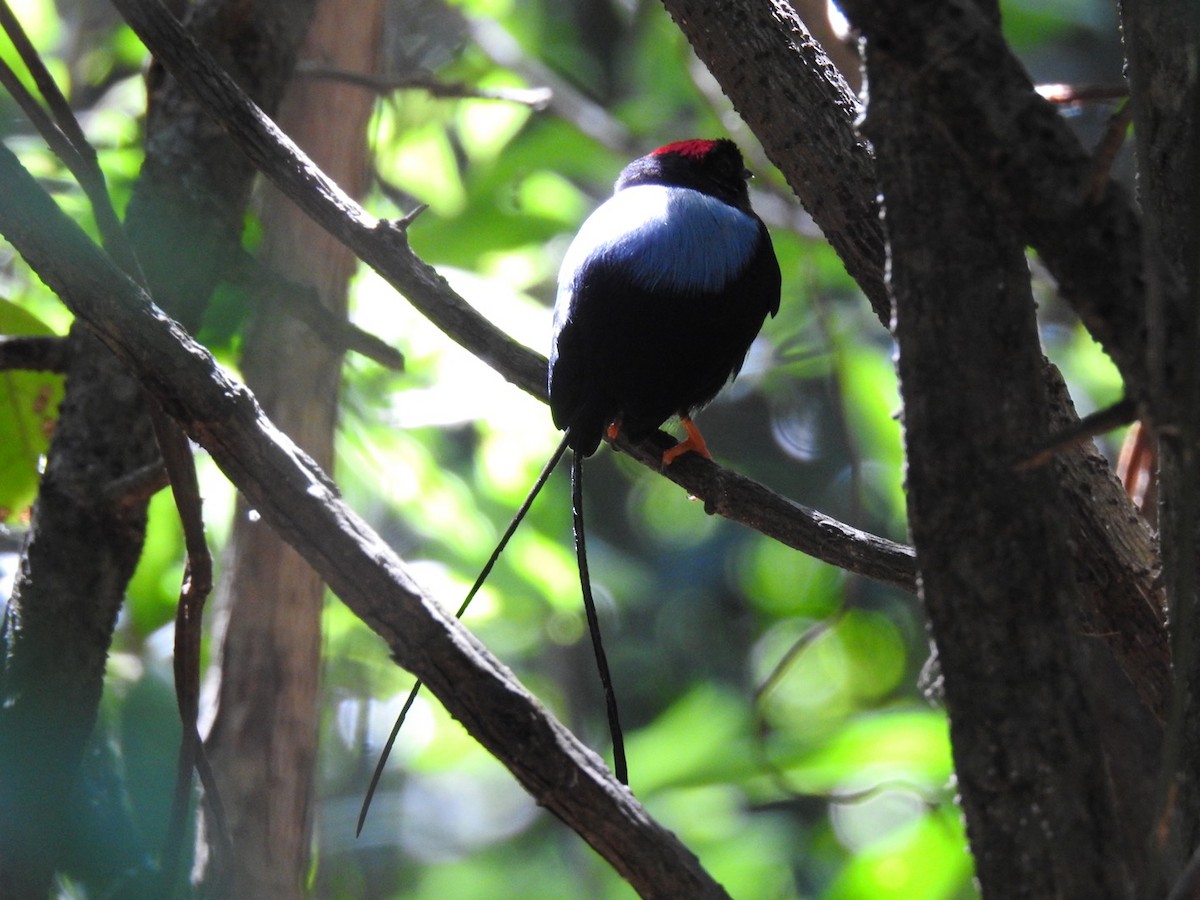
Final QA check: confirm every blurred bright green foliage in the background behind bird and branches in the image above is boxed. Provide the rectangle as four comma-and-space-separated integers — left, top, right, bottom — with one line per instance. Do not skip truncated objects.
0, 0, 1121, 900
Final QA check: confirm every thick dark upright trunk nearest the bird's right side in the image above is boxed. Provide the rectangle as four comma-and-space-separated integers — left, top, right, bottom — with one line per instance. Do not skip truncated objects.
864, 15, 1132, 898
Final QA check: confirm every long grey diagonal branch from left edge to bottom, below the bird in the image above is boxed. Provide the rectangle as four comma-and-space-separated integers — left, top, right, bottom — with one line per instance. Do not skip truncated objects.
0, 141, 726, 898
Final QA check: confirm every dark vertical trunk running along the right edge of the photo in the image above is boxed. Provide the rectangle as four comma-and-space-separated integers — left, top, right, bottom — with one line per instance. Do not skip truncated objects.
1121, 0, 1200, 878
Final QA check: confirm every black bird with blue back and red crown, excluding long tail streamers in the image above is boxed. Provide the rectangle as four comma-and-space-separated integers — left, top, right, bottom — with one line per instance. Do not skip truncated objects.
548, 139, 780, 464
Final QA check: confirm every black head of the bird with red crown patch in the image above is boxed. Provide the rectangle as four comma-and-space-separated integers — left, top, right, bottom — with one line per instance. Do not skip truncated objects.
616, 138, 750, 212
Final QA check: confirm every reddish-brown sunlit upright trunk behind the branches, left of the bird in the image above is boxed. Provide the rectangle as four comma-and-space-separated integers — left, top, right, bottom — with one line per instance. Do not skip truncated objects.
208, 0, 383, 899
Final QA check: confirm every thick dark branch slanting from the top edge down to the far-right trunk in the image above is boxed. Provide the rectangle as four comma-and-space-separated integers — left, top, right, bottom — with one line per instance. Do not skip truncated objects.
842, 0, 1150, 402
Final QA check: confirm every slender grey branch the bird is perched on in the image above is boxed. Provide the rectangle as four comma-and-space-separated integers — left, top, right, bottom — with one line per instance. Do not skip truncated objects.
115, 0, 916, 589
